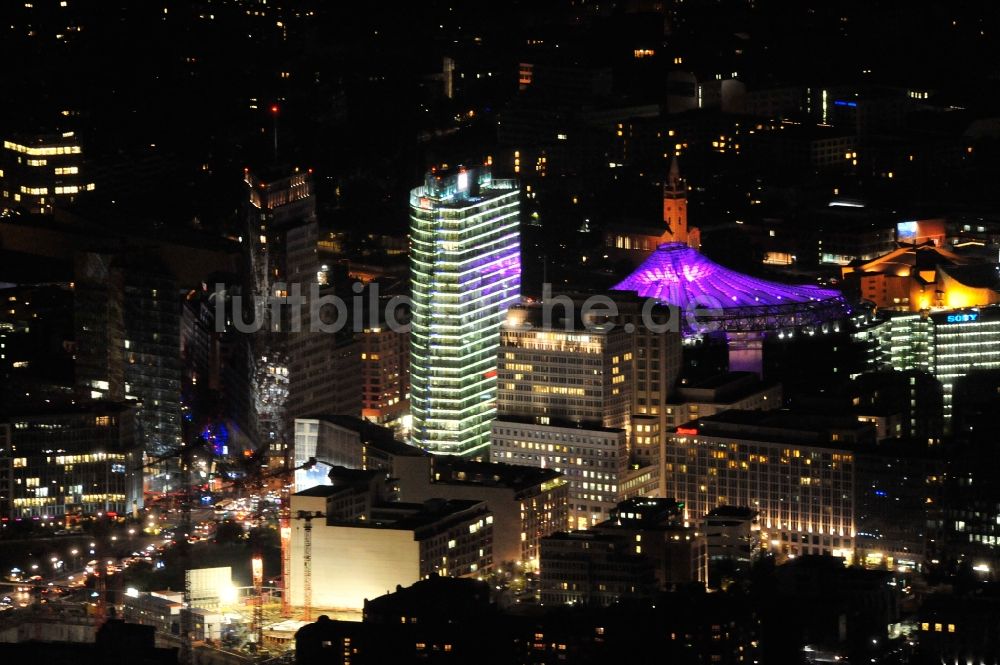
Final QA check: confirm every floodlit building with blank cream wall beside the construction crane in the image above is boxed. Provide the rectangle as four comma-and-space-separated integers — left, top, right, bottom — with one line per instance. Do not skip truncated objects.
288, 482, 493, 612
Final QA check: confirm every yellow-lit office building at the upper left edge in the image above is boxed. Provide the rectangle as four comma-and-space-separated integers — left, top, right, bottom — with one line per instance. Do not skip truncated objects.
0, 132, 94, 214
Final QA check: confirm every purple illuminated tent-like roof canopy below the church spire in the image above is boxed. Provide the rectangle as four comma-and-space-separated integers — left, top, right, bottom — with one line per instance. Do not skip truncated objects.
612, 243, 848, 330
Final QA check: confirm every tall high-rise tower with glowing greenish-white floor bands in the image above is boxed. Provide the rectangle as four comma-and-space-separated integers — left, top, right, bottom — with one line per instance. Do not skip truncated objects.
410, 167, 521, 456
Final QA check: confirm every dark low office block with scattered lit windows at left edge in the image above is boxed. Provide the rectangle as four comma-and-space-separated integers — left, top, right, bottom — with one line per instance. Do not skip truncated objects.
0, 401, 142, 520
